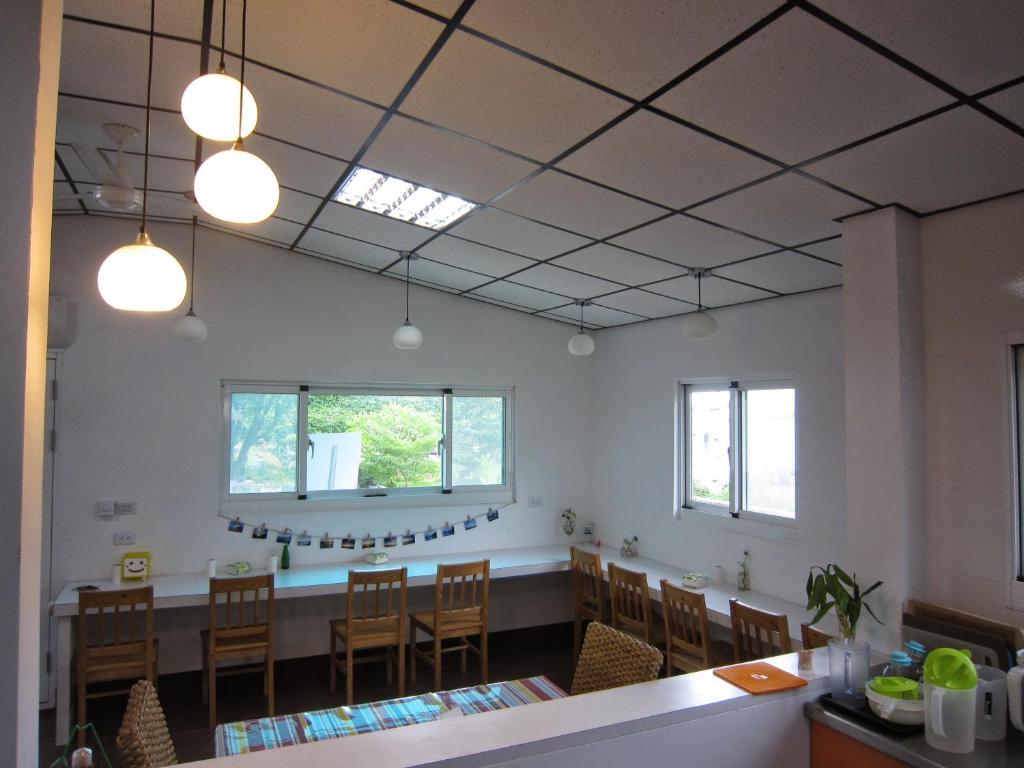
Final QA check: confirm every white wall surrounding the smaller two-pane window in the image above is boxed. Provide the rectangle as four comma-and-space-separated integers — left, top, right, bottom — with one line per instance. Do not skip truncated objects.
593, 290, 845, 614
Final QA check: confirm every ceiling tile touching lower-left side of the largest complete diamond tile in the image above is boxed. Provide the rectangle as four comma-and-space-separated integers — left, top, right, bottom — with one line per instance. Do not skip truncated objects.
558, 112, 778, 208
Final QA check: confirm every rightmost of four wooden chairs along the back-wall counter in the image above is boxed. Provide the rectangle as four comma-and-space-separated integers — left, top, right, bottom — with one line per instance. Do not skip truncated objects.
409, 560, 490, 690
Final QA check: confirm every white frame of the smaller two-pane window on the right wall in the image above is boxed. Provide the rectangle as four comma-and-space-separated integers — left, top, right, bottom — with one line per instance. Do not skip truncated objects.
677, 379, 800, 528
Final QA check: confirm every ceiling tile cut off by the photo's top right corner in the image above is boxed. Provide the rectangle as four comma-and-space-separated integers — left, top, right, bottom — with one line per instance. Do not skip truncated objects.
817, 0, 1024, 93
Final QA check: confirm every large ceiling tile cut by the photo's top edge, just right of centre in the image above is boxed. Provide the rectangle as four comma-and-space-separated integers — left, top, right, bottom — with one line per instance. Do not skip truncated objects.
466, 0, 777, 98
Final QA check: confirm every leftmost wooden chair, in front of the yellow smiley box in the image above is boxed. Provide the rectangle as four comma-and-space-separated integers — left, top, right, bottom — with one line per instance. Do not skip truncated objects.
77, 587, 157, 745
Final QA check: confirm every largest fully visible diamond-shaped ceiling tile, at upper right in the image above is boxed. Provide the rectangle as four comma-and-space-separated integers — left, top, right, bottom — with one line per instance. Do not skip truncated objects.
654, 10, 952, 163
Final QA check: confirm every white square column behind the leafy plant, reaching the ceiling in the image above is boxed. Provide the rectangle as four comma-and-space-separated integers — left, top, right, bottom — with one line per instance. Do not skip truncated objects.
843, 207, 925, 651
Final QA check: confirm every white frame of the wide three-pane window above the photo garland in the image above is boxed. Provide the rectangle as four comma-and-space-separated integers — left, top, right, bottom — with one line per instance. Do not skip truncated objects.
220, 380, 515, 514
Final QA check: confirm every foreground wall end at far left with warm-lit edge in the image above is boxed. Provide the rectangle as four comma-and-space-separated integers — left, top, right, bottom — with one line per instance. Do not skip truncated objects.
0, 0, 61, 768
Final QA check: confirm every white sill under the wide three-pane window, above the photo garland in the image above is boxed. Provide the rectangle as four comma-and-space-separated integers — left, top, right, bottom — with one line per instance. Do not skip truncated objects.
220, 490, 515, 517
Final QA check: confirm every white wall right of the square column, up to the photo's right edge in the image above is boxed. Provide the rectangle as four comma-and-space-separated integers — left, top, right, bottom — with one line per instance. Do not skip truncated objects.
922, 195, 1024, 626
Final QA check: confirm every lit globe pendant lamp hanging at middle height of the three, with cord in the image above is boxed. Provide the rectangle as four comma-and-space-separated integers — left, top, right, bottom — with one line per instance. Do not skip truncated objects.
196, 0, 281, 224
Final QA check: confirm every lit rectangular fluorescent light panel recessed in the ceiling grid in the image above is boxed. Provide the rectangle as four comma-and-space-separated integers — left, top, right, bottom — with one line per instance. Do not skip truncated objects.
334, 167, 476, 229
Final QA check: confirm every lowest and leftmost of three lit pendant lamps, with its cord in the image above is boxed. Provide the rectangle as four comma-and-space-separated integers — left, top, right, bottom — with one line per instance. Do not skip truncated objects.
96, 0, 187, 312
